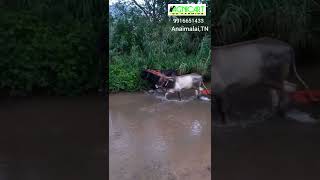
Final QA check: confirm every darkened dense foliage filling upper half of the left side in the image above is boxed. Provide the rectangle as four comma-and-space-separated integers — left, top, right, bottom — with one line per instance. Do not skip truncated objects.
0, 0, 102, 95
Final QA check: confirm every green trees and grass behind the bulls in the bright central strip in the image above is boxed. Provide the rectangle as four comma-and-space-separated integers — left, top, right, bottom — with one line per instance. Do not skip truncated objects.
109, 1, 211, 92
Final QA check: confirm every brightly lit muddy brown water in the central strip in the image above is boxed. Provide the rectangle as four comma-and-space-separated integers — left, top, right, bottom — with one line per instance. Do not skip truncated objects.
109, 93, 211, 180
